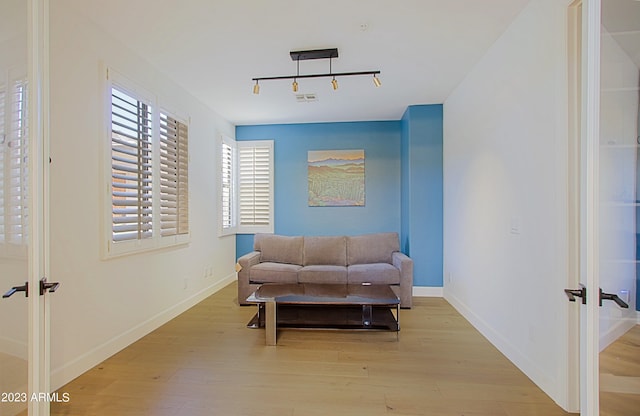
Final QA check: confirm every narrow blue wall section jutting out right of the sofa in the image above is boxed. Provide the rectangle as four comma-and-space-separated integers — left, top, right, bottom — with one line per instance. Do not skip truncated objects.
400, 105, 443, 287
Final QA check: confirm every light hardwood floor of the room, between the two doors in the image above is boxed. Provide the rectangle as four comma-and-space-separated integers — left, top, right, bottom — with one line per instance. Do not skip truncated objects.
51, 284, 568, 416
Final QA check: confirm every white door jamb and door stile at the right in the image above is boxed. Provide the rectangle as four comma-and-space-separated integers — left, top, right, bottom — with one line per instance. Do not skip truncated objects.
567, 0, 601, 416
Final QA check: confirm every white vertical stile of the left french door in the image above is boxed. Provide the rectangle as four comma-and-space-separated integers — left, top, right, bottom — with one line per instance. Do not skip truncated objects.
27, 0, 51, 416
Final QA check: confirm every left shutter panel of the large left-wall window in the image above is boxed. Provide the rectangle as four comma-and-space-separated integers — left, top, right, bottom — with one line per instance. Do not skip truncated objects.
111, 87, 153, 241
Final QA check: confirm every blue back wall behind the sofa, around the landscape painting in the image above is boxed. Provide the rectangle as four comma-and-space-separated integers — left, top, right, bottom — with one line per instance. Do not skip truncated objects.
236, 121, 400, 256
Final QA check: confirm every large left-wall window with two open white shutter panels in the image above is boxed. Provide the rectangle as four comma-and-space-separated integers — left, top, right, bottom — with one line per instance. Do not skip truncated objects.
105, 71, 189, 256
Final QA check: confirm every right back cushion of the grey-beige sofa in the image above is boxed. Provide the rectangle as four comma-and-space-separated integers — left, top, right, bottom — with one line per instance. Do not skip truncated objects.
347, 233, 400, 264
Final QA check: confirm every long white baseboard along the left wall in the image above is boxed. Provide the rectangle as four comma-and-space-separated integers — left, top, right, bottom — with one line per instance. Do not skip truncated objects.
51, 273, 237, 391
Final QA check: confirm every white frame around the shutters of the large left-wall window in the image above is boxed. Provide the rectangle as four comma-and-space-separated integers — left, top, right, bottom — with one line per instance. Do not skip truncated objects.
101, 68, 191, 259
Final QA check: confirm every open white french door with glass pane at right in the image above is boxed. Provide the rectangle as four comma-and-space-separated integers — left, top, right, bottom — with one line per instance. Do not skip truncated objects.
573, 0, 640, 416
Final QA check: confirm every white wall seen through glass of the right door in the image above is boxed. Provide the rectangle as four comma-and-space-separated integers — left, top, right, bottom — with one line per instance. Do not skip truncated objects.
599, 24, 640, 349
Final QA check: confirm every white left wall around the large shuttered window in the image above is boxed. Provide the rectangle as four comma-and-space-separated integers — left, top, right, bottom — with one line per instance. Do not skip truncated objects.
49, 1, 235, 388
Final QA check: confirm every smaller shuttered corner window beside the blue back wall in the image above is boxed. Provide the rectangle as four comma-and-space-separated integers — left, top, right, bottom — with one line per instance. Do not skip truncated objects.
220, 138, 274, 235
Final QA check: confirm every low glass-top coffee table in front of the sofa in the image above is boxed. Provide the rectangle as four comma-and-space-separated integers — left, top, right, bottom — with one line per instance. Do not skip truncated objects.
247, 283, 400, 345
